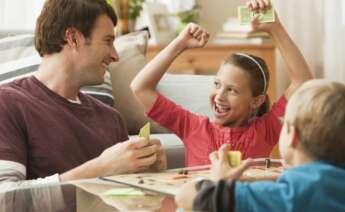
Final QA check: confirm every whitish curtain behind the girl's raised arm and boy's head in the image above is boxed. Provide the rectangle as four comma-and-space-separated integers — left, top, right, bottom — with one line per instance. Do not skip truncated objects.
274, 0, 345, 94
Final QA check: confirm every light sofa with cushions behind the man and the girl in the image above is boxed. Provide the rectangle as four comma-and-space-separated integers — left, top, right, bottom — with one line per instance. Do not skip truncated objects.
0, 32, 213, 168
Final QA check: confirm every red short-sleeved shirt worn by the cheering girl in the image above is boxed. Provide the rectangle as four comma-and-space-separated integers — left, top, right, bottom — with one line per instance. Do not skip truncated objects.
147, 95, 287, 166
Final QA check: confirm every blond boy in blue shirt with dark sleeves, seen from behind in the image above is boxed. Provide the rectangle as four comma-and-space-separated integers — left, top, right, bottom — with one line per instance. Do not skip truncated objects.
176, 80, 345, 211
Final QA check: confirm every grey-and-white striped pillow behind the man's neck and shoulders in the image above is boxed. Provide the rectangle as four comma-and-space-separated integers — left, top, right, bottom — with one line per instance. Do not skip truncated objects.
0, 34, 114, 106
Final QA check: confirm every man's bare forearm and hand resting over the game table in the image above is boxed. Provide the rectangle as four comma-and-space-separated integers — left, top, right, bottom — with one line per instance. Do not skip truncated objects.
59, 138, 166, 182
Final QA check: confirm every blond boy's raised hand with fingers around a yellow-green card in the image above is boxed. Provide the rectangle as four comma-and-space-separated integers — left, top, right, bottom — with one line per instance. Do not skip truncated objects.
210, 144, 252, 181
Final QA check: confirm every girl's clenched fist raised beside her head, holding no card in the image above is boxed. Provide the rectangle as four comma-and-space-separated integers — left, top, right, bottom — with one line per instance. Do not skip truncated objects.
176, 23, 210, 49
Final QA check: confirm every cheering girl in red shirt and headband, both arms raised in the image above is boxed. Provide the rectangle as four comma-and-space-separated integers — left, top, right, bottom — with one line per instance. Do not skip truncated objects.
131, 0, 311, 166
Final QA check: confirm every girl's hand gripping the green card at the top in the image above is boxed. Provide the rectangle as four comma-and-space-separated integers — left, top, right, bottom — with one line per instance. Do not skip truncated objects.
246, 0, 280, 33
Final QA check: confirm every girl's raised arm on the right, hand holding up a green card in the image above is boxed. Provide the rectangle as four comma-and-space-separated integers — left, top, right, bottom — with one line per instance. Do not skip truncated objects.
247, 0, 313, 98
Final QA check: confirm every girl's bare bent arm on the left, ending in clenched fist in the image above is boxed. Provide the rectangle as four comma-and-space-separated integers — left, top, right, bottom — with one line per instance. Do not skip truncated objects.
131, 24, 209, 111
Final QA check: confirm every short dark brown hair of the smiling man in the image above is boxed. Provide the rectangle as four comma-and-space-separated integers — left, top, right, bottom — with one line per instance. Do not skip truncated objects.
34, 0, 117, 56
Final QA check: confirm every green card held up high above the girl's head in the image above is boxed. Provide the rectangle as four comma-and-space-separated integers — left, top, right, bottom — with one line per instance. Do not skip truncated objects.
238, 6, 275, 25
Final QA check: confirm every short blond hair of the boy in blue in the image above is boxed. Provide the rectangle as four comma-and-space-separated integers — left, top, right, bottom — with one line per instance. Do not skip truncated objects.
285, 79, 345, 167
